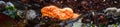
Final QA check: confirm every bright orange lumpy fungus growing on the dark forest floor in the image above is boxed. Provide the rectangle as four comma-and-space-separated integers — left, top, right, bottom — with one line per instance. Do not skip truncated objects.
41, 6, 79, 20
